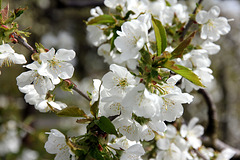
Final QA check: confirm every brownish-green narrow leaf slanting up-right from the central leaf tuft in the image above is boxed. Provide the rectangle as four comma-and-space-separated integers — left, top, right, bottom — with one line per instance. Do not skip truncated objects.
171, 31, 196, 59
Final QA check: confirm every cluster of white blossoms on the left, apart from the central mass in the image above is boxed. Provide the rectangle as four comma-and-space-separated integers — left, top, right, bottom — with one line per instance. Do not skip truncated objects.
17, 48, 76, 112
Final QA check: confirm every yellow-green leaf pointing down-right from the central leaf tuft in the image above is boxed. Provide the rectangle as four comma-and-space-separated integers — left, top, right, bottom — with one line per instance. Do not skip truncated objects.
163, 61, 205, 87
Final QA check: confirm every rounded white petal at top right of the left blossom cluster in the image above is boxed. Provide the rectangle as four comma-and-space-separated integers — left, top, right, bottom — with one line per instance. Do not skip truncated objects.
55, 49, 76, 61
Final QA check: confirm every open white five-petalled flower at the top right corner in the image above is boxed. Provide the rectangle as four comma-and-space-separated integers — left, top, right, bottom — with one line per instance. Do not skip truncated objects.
196, 6, 231, 41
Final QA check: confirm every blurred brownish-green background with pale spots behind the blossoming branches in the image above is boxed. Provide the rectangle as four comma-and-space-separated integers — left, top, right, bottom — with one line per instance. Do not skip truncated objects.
0, 0, 240, 160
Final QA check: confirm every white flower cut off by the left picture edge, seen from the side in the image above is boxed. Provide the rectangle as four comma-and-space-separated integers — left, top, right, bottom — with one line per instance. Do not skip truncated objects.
0, 44, 27, 66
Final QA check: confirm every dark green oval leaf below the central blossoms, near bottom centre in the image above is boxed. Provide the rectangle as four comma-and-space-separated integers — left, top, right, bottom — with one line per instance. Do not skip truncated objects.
95, 116, 117, 135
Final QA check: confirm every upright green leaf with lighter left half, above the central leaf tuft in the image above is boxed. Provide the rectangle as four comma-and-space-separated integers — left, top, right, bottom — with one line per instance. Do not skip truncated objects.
152, 16, 167, 55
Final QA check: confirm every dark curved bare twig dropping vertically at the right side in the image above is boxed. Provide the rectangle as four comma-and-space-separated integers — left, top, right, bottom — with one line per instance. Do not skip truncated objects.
198, 89, 217, 139
